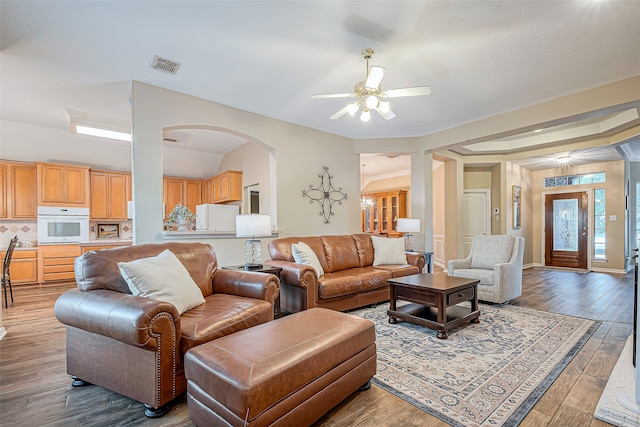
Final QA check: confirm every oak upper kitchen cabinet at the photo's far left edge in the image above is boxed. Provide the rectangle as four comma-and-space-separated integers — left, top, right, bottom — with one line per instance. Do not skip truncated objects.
0, 161, 37, 219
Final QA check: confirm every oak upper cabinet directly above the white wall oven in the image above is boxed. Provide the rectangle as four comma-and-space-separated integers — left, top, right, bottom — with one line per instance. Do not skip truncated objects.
36, 163, 90, 208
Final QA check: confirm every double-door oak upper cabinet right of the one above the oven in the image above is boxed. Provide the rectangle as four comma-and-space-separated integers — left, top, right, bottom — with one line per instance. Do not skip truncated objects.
89, 171, 131, 221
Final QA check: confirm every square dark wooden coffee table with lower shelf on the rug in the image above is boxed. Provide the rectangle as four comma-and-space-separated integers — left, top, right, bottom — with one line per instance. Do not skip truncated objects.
387, 274, 480, 339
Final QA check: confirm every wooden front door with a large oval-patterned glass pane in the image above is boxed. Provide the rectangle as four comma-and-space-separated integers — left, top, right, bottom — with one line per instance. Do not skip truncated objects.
544, 191, 589, 269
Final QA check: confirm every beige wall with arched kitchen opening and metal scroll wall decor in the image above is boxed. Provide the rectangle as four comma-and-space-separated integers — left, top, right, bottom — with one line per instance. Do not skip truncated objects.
132, 82, 360, 265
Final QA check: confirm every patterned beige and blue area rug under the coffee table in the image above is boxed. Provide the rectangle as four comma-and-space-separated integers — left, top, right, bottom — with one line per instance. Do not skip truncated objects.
350, 304, 600, 427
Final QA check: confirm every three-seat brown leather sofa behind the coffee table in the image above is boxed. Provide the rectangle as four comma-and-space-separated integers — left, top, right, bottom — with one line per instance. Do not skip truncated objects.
265, 234, 426, 313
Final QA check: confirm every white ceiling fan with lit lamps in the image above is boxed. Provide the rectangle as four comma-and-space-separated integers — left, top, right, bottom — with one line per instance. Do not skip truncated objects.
310, 48, 431, 122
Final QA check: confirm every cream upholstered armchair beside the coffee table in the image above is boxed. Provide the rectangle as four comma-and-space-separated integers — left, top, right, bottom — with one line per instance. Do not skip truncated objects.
449, 235, 524, 303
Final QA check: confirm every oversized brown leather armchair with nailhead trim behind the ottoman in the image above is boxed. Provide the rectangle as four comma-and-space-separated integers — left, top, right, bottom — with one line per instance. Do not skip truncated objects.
55, 243, 279, 417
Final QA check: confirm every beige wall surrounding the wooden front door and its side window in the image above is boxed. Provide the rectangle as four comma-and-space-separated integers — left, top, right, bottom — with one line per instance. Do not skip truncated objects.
523, 160, 626, 272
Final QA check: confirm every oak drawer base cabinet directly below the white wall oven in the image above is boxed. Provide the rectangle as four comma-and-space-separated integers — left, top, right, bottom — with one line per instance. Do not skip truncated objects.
37, 244, 82, 283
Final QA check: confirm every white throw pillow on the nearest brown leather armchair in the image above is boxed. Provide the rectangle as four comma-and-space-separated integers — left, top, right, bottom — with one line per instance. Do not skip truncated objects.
118, 249, 204, 314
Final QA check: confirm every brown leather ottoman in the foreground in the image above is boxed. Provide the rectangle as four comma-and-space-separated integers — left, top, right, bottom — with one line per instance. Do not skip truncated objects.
184, 308, 376, 427
